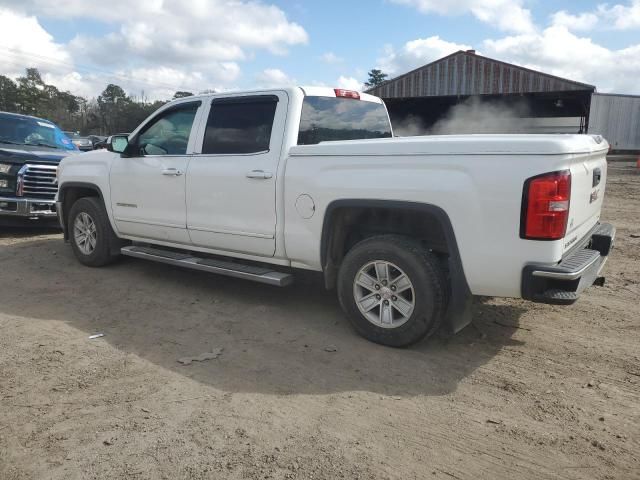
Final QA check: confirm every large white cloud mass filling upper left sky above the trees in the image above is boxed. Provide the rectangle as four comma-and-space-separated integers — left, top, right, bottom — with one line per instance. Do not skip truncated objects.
0, 0, 308, 98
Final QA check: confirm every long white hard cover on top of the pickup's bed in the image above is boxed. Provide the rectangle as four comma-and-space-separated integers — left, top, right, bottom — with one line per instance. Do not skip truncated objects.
290, 134, 609, 156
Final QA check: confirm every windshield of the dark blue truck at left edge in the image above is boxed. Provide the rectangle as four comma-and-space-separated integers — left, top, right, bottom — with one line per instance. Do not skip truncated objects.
0, 115, 76, 150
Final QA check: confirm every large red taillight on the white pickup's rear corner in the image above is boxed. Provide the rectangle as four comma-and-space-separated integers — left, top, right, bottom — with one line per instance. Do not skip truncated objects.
520, 170, 571, 240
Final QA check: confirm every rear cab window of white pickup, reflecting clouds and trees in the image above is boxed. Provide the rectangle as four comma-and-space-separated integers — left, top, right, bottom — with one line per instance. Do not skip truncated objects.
298, 97, 391, 145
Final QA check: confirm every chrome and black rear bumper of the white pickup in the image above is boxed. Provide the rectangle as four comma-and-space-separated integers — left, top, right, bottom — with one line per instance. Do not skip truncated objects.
522, 223, 616, 305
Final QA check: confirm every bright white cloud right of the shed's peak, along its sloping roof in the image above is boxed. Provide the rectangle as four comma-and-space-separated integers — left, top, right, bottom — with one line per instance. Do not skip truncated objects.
483, 25, 640, 93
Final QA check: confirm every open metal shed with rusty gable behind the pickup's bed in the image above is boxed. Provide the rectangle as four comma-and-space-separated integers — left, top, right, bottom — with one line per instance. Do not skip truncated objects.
368, 50, 595, 134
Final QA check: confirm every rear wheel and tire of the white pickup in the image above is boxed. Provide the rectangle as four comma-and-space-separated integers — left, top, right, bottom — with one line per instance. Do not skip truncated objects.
338, 235, 447, 347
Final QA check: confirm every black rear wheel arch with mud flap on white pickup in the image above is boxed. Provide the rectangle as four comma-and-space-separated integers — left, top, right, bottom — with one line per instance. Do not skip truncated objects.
320, 199, 471, 332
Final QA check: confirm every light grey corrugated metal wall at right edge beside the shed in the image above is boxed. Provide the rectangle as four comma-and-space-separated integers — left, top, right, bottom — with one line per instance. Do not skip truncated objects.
589, 93, 640, 150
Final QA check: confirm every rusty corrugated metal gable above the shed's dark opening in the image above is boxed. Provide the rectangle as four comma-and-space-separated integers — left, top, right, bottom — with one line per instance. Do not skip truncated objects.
369, 52, 593, 98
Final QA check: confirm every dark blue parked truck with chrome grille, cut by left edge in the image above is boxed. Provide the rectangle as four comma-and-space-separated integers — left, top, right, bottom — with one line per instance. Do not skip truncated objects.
0, 112, 78, 223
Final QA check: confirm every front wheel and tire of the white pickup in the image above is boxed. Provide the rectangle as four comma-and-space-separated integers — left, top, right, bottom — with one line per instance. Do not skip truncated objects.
67, 197, 120, 267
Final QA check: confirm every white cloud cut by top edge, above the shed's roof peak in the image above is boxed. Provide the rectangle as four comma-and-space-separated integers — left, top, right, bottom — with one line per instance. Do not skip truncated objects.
391, 0, 535, 33
